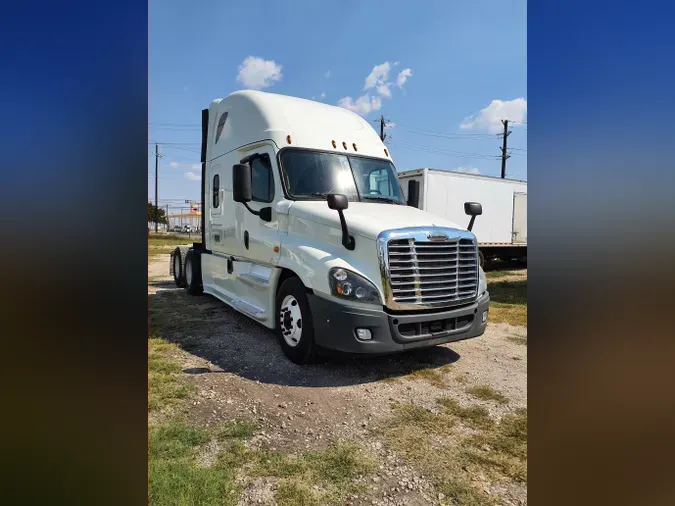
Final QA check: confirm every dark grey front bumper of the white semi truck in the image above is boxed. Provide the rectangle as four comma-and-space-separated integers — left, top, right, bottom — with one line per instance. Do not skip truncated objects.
308, 292, 490, 354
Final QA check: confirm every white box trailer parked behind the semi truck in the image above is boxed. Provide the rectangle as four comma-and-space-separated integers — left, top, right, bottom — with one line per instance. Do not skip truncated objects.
399, 168, 527, 258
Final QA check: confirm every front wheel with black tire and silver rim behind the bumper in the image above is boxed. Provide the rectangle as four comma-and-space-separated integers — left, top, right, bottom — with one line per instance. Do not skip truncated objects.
275, 277, 316, 364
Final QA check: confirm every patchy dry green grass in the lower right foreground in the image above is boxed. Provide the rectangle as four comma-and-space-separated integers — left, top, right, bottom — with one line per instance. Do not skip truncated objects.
379, 397, 527, 506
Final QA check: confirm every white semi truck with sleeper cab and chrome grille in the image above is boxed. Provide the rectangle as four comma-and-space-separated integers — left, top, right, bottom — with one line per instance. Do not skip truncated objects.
170, 90, 489, 363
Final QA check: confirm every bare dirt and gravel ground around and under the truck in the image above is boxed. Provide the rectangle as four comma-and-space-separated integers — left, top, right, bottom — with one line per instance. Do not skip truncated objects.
148, 255, 527, 505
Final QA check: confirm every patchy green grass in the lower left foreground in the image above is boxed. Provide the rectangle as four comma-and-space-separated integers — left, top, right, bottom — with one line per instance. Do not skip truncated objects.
148, 337, 375, 506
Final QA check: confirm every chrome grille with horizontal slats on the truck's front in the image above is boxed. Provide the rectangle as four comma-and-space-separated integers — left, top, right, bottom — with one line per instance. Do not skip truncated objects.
387, 238, 478, 307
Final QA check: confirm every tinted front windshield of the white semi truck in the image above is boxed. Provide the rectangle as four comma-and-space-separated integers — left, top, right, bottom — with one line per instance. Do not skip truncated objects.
281, 149, 404, 204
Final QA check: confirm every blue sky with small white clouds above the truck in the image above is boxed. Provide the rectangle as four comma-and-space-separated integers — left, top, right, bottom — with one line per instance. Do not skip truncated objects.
148, 0, 527, 208
